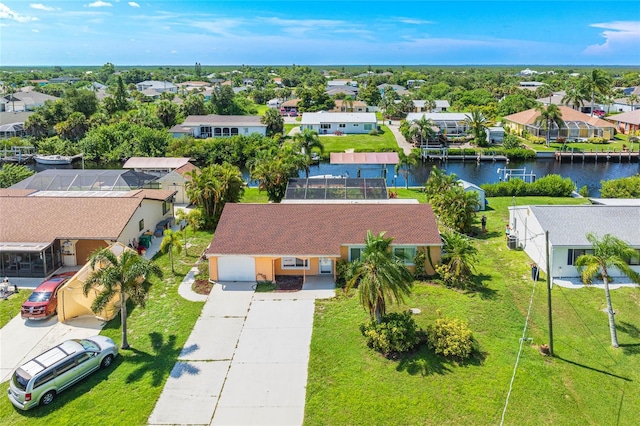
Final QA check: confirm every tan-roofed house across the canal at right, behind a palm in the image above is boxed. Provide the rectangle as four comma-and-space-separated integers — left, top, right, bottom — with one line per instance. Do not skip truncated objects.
502, 105, 615, 140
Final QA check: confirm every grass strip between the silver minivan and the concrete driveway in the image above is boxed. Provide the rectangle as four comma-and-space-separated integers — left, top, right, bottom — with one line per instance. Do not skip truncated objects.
0, 231, 212, 426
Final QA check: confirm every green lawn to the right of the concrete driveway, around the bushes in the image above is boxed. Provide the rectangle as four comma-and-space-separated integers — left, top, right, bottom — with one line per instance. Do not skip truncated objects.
305, 198, 640, 425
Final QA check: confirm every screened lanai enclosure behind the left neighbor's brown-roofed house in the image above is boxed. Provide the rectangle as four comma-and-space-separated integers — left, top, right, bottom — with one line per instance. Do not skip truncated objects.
12, 169, 160, 191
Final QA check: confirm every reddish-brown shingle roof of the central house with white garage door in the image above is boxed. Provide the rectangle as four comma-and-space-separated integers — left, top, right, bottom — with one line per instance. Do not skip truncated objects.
207, 204, 441, 256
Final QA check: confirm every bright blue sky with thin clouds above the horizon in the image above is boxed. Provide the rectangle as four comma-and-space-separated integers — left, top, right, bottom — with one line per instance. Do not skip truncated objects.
0, 0, 640, 66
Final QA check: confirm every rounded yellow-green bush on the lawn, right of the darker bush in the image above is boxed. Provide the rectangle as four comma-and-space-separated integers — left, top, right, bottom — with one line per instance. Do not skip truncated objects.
427, 317, 474, 359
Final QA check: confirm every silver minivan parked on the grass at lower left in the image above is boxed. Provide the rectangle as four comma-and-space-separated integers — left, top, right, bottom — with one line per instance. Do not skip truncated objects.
7, 336, 118, 410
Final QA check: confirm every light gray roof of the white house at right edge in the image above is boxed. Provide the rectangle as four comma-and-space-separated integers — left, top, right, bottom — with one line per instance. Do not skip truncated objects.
530, 205, 640, 247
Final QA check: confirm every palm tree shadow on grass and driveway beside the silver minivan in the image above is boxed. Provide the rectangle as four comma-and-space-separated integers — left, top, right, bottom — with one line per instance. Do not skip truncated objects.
126, 332, 199, 386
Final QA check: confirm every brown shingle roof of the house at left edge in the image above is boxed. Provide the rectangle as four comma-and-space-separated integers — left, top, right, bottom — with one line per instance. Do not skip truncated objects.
0, 196, 141, 242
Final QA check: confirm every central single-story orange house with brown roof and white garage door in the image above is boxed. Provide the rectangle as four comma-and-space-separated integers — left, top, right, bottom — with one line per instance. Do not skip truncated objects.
206, 203, 442, 282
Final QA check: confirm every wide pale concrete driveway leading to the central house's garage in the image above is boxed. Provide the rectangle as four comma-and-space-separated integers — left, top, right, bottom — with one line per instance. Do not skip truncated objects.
149, 277, 335, 425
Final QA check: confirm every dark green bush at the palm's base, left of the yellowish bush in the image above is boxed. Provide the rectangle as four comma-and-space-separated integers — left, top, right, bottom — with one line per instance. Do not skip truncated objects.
360, 312, 420, 355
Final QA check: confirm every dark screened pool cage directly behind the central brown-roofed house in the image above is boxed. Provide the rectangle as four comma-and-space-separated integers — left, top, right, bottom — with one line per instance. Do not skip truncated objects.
285, 177, 388, 200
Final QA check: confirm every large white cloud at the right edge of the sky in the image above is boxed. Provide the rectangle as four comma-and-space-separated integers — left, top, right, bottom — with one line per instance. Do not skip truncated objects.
584, 21, 640, 57
